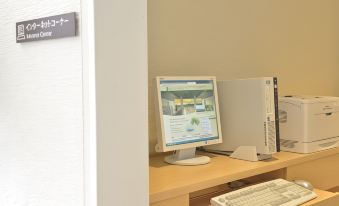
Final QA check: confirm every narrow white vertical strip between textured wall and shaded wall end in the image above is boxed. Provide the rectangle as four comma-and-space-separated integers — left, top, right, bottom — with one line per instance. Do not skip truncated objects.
81, 0, 97, 206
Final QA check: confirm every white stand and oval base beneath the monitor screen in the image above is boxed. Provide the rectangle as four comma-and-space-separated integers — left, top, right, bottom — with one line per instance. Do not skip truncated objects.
165, 147, 211, 165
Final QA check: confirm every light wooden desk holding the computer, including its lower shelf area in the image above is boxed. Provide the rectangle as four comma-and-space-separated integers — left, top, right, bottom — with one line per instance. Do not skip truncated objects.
149, 148, 339, 206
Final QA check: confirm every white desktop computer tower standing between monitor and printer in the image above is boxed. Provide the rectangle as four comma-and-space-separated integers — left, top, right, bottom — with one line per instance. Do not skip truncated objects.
204, 77, 280, 161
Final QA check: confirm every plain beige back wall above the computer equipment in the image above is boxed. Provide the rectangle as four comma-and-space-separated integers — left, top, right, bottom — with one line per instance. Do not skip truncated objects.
148, 0, 339, 154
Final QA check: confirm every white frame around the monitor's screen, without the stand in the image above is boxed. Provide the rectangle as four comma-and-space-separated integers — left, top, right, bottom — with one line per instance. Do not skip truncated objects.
155, 76, 222, 152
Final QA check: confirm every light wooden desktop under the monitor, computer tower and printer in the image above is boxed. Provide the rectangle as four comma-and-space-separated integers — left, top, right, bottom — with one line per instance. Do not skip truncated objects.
149, 148, 339, 203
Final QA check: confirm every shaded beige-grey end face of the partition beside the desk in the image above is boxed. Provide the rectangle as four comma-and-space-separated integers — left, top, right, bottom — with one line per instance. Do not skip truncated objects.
94, 0, 148, 206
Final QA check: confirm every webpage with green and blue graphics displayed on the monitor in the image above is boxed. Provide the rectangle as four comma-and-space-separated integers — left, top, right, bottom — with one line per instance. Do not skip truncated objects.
160, 80, 219, 146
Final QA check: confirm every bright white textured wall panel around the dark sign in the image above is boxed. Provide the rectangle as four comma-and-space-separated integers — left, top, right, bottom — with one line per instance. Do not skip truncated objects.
0, 0, 84, 206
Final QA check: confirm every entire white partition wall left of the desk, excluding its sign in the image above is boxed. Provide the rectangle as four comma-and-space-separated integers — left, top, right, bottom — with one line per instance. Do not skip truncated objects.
0, 0, 148, 206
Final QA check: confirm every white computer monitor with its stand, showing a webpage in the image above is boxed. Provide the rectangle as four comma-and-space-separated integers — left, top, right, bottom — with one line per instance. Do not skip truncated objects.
155, 77, 222, 165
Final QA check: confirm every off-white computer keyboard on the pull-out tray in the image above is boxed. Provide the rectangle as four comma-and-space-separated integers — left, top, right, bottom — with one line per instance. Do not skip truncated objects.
211, 179, 317, 206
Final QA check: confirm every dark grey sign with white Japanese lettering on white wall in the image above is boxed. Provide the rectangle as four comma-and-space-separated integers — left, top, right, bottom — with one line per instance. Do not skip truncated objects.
16, 12, 76, 43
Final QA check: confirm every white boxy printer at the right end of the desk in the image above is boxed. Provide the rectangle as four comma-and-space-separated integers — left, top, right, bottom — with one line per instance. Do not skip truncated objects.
279, 96, 339, 153
